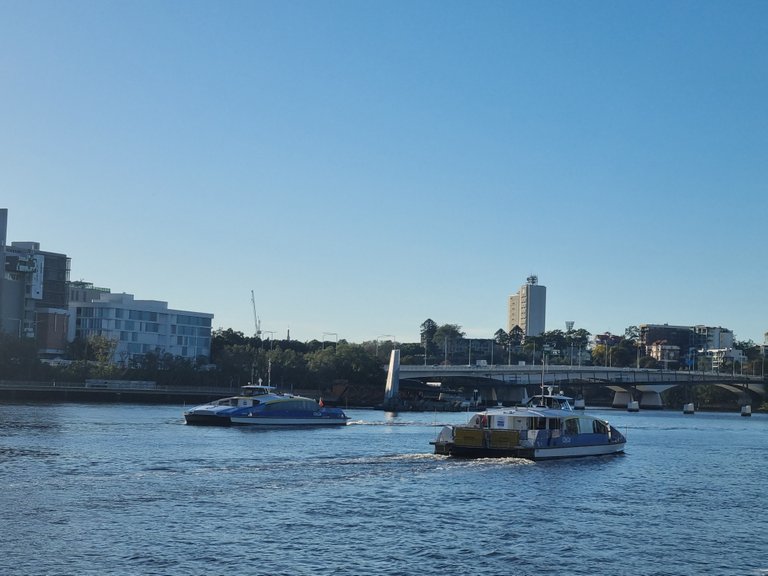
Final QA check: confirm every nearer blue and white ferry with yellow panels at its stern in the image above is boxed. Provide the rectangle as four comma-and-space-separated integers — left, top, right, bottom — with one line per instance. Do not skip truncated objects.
431, 392, 626, 460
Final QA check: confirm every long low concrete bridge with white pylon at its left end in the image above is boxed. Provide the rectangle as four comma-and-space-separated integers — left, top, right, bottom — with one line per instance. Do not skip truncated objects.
385, 350, 766, 408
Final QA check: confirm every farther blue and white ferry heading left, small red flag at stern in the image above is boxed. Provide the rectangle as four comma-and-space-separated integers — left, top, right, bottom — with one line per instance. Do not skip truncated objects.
184, 384, 349, 426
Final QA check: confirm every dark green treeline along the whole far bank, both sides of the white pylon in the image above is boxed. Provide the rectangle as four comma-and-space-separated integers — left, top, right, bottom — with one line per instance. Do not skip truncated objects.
0, 319, 764, 401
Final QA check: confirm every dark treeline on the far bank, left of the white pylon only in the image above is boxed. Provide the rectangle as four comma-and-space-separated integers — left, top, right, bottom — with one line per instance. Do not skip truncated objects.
0, 329, 393, 404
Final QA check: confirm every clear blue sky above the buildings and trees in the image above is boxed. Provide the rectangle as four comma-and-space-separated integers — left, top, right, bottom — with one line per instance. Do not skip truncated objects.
0, 0, 768, 342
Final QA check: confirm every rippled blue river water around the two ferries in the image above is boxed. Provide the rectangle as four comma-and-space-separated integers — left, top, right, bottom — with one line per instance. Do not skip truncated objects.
0, 404, 768, 576
